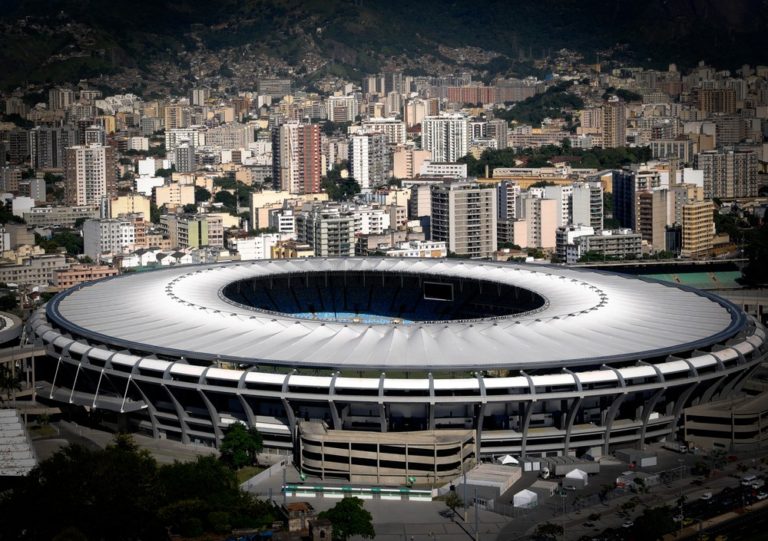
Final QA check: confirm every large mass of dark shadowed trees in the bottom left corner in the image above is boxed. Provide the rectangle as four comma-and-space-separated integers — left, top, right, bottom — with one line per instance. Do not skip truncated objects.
0, 435, 275, 541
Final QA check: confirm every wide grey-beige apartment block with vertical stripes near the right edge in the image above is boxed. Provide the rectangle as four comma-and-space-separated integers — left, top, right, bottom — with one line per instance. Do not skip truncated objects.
693, 150, 758, 199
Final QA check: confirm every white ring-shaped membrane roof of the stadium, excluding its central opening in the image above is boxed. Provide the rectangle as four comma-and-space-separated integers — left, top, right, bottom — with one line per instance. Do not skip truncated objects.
47, 258, 745, 371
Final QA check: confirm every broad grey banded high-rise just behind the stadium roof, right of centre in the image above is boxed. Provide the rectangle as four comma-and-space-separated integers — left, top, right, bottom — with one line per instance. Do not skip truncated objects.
431, 181, 498, 257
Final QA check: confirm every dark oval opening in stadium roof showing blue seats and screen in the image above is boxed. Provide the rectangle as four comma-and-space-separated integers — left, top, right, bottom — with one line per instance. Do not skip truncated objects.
221, 271, 547, 325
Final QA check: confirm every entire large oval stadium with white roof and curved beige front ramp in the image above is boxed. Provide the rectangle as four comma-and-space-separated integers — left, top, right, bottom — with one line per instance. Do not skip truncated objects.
27, 258, 768, 483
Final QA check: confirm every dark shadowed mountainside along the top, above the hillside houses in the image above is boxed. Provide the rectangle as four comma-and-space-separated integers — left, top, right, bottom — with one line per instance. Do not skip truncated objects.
0, 0, 768, 87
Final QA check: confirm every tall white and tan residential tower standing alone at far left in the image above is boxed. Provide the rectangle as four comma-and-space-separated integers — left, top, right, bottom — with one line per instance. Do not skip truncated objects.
64, 145, 117, 205
